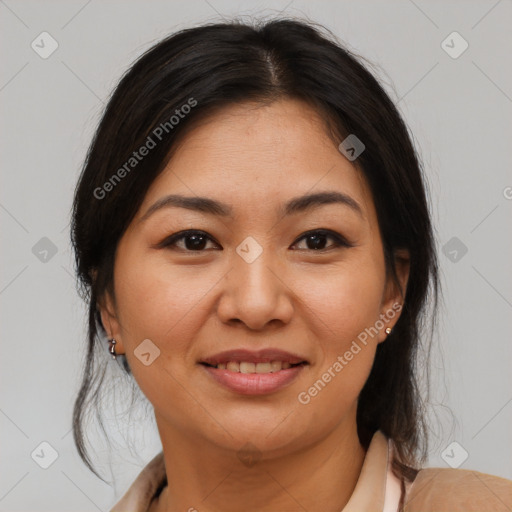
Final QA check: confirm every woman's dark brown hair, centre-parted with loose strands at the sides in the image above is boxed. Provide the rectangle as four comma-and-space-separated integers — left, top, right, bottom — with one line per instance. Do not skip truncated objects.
72, 19, 440, 484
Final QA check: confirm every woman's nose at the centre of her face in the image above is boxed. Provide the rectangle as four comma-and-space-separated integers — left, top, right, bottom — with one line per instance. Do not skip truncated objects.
217, 249, 294, 331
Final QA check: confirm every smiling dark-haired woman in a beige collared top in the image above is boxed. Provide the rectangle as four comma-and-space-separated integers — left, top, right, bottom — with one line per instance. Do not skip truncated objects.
72, 20, 512, 512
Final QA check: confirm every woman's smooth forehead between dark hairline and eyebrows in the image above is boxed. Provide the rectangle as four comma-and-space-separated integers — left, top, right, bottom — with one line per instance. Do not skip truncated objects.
136, 99, 373, 222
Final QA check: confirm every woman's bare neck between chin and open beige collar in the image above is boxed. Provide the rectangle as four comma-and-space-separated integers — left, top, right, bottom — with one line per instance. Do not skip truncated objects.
152, 410, 365, 512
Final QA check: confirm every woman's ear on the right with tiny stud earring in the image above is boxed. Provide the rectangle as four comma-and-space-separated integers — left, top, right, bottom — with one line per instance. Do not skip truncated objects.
378, 249, 411, 343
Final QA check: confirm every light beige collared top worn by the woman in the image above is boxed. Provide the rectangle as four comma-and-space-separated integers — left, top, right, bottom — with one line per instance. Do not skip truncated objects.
110, 431, 512, 512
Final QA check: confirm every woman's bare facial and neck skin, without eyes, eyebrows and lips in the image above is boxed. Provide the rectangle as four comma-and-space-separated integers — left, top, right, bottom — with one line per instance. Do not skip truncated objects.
101, 99, 409, 512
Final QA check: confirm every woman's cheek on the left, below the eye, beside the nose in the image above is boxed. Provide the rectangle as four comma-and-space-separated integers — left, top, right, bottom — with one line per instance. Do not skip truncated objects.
114, 250, 218, 416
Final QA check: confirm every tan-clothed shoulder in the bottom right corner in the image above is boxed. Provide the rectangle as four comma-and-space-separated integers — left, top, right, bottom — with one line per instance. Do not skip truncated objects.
403, 468, 512, 512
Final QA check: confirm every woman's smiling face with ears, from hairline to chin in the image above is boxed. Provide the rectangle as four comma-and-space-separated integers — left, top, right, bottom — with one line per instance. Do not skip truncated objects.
102, 100, 408, 455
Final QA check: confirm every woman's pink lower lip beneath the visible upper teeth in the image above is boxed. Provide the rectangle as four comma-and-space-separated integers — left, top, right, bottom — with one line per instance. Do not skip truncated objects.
201, 364, 304, 395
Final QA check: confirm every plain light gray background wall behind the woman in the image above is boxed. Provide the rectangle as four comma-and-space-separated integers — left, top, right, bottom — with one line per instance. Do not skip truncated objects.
0, 0, 512, 512
